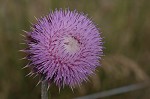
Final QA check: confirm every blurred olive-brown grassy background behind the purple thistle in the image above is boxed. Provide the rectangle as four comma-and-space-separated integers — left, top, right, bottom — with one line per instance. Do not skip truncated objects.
0, 0, 150, 99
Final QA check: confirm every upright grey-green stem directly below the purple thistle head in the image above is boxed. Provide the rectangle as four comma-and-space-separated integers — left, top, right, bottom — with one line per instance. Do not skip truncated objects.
41, 80, 48, 99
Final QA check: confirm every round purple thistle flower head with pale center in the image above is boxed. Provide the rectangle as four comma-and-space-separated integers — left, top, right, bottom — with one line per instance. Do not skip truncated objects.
24, 9, 103, 88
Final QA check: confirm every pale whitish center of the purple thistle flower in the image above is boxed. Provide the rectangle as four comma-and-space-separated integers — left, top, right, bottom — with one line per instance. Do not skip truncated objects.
63, 36, 79, 53
